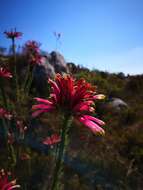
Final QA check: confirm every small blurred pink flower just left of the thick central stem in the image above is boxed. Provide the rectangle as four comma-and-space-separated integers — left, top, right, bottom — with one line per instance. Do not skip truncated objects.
43, 134, 61, 145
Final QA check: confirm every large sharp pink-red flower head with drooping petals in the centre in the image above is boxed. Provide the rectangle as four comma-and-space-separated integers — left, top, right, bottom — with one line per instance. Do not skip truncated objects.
32, 74, 105, 134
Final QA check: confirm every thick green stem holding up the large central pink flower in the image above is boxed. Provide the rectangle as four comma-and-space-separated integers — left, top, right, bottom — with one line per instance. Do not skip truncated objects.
51, 116, 71, 190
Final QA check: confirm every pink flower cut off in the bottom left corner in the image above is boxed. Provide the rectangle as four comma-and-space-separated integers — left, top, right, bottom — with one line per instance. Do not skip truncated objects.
0, 169, 20, 190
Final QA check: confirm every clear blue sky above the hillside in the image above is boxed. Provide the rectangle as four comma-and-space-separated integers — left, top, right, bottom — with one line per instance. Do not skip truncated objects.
0, 0, 143, 74
